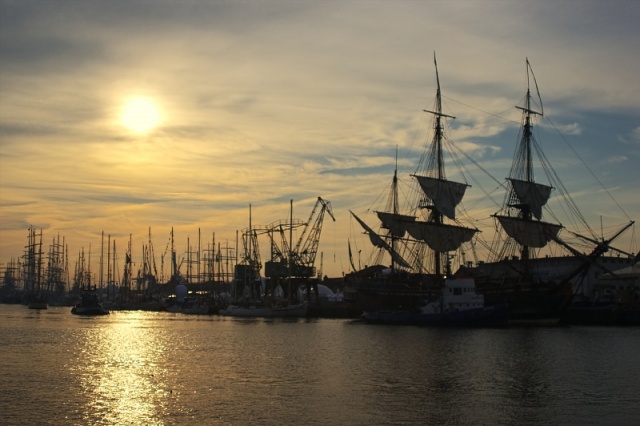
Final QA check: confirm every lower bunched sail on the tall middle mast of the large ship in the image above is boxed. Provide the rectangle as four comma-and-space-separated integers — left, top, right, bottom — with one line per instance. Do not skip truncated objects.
405, 221, 478, 253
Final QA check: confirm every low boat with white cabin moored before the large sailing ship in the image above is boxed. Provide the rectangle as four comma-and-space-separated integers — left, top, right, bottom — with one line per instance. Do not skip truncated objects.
362, 278, 509, 327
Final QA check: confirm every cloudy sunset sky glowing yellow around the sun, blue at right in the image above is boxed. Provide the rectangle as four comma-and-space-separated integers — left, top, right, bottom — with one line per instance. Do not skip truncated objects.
0, 0, 640, 276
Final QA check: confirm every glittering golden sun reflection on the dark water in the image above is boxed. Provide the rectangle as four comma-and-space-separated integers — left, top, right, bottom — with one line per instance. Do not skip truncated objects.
76, 314, 171, 424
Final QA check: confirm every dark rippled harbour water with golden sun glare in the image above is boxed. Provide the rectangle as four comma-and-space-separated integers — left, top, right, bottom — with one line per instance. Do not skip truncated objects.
0, 305, 640, 425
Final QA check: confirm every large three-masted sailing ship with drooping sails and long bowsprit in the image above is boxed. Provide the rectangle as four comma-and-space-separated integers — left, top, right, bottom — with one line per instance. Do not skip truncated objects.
345, 57, 634, 320
